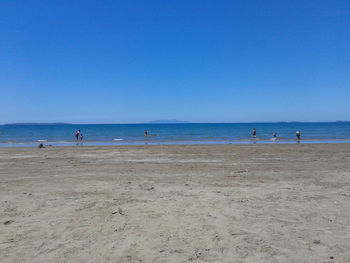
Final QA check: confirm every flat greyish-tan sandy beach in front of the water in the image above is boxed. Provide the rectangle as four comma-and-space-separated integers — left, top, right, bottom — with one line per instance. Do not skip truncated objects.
0, 144, 350, 263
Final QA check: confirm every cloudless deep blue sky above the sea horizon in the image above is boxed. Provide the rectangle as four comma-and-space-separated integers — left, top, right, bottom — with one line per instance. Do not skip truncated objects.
0, 0, 350, 123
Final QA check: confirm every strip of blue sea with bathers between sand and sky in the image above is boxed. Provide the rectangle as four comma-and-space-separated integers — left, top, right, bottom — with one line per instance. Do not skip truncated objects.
0, 122, 350, 147
